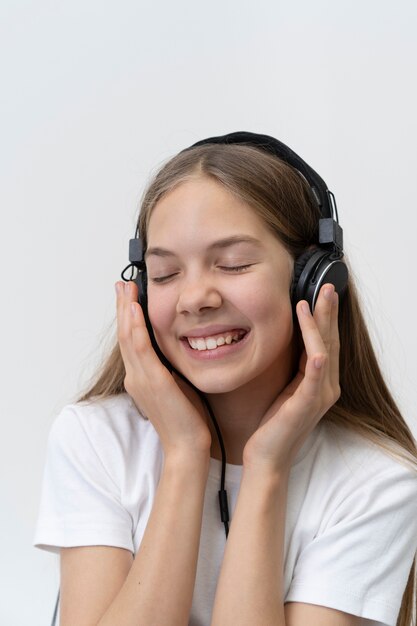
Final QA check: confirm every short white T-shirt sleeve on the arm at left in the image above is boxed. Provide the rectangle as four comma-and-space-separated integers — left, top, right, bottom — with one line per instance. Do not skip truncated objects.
33, 405, 134, 553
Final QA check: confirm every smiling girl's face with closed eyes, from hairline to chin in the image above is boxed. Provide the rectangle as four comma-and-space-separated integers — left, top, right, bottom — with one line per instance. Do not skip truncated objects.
145, 177, 293, 393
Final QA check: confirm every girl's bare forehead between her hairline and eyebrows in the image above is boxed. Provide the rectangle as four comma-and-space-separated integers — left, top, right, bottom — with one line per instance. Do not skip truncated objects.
147, 178, 278, 246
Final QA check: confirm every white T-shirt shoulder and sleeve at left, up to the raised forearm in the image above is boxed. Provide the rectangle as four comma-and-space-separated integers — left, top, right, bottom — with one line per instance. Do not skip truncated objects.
35, 394, 156, 552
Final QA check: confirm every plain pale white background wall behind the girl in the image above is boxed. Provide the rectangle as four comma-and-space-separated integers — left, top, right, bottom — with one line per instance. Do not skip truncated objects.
0, 0, 417, 626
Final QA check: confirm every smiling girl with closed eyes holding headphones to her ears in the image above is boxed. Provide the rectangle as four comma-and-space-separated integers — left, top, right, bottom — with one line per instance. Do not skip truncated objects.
34, 133, 417, 626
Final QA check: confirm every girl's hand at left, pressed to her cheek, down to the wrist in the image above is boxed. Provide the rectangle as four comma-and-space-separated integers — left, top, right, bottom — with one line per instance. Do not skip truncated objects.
115, 281, 211, 456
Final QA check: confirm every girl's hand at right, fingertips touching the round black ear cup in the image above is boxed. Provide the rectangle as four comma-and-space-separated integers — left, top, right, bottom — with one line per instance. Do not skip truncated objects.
243, 283, 340, 473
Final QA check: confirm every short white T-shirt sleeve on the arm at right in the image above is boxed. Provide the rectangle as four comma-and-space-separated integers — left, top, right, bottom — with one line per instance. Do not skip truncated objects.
285, 463, 417, 626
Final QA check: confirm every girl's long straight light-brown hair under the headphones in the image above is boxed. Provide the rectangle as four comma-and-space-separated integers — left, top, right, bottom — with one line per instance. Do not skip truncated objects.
76, 144, 417, 626
